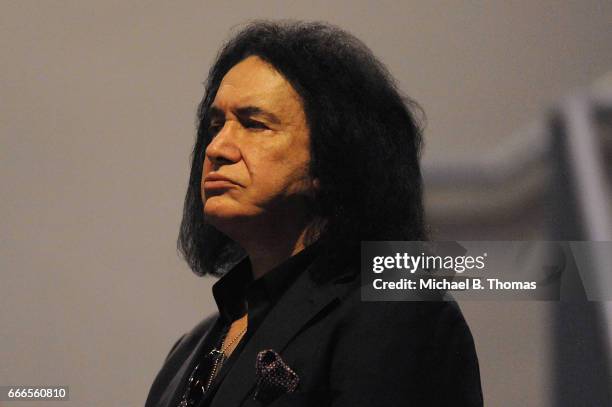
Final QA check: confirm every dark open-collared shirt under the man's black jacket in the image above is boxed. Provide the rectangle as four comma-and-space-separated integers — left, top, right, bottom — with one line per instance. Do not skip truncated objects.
185, 243, 319, 400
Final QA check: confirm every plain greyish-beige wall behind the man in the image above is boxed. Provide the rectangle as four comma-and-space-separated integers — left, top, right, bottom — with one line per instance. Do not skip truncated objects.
0, 0, 612, 406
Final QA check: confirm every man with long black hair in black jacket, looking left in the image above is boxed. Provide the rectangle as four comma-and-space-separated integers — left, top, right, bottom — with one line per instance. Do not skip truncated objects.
146, 22, 482, 407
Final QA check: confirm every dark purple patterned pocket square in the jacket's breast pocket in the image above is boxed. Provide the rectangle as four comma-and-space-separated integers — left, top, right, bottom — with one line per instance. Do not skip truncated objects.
254, 349, 300, 403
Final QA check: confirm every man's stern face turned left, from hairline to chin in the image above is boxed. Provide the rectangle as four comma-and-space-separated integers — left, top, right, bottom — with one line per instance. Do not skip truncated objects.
201, 56, 311, 231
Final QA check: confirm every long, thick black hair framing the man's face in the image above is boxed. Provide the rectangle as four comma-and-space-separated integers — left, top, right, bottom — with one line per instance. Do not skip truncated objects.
177, 21, 426, 275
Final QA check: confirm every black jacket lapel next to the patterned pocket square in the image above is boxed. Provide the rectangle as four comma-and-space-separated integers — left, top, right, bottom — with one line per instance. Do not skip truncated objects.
209, 256, 356, 407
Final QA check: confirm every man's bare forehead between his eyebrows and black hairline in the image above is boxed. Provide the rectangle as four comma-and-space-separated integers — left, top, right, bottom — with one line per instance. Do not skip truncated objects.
213, 56, 298, 109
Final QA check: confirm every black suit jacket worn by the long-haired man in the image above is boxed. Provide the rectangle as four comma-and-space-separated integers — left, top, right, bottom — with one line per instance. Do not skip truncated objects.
146, 252, 483, 407
